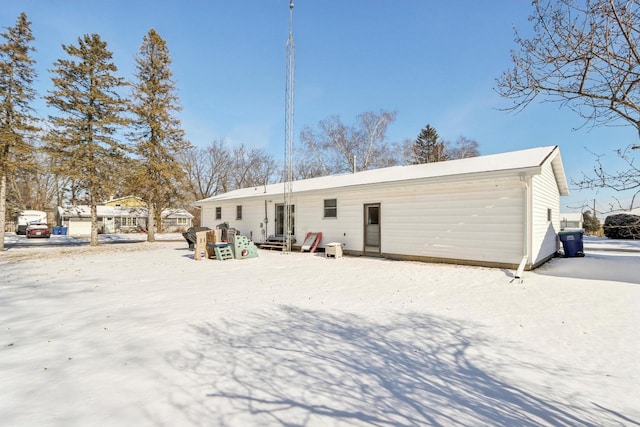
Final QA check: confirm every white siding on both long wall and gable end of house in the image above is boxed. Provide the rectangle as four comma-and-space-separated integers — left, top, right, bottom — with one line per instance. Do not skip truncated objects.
196, 147, 567, 267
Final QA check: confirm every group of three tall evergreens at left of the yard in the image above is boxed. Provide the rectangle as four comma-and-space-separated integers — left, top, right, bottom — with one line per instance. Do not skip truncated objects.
0, 13, 196, 246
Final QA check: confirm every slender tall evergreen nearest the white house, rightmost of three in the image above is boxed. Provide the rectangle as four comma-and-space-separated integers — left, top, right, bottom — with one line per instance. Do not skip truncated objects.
130, 29, 189, 242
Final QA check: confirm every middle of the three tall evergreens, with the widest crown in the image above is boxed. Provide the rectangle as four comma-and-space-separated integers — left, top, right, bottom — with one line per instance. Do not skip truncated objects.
46, 34, 128, 246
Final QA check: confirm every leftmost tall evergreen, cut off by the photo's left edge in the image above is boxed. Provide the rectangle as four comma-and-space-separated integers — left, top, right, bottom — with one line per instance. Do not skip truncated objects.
0, 12, 38, 250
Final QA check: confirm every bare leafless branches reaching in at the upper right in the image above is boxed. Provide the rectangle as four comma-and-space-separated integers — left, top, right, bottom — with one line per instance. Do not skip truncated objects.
497, 0, 640, 210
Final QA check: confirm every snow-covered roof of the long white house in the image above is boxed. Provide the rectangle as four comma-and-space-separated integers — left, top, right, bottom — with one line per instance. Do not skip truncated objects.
195, 146, 569, 206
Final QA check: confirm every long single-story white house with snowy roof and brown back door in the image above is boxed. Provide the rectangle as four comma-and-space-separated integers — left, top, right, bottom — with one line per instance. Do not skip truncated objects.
195, 146, 569, 269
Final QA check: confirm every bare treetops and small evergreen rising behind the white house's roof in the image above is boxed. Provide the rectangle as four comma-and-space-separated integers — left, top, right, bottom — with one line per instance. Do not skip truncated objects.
181, 110, 479, 194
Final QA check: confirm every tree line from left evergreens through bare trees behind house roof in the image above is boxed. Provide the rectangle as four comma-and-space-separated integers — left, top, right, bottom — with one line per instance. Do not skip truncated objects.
0, 13, 478, 251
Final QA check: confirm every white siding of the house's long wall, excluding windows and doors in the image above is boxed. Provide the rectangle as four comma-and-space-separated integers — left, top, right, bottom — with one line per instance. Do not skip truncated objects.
203, 178, 525, 263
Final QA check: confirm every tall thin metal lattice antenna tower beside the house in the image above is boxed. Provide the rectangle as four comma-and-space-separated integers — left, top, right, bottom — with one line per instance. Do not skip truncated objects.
283, 0, 295, 253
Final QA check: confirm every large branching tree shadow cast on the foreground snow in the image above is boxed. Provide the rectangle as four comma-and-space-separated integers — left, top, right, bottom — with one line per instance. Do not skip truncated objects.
168, 307, 620, 426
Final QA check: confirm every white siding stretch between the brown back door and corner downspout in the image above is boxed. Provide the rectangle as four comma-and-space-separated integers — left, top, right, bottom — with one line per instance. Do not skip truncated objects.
381, 180, 524, 263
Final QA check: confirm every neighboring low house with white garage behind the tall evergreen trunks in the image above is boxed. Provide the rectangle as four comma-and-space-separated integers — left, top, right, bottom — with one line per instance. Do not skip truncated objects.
57, 205, 193, 236
